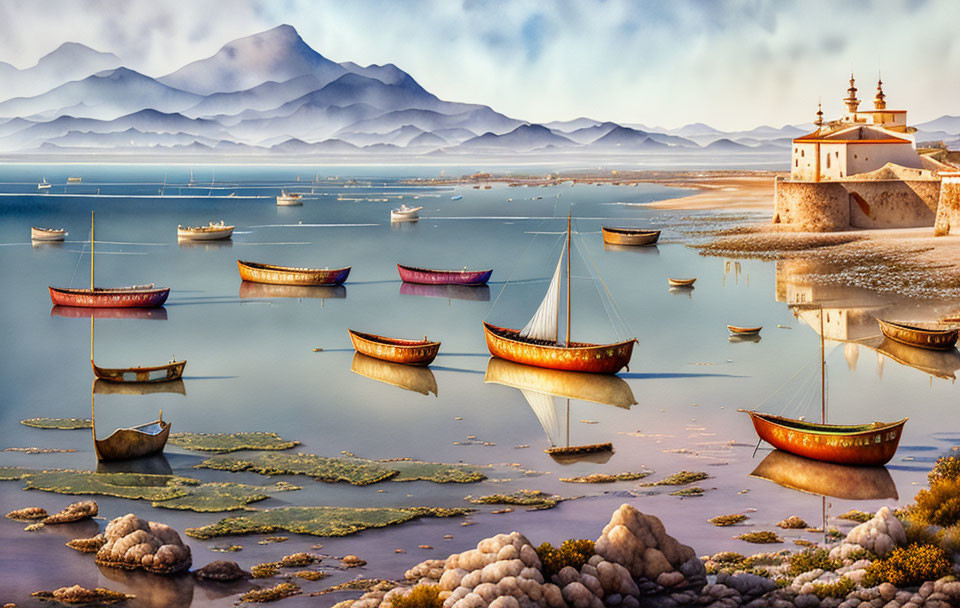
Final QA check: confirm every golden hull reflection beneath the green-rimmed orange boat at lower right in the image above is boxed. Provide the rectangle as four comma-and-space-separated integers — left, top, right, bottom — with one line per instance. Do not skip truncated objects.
750, 450, 899, 500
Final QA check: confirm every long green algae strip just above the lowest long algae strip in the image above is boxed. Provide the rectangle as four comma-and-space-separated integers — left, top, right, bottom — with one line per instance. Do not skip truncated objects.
196, 452, 486, 486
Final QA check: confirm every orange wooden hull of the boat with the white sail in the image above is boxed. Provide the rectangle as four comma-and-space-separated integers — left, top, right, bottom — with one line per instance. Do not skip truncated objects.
483, 322, 636, 374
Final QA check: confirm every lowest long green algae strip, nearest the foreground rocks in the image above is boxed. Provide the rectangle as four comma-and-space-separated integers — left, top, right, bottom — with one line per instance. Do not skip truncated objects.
184, 507, 470, 540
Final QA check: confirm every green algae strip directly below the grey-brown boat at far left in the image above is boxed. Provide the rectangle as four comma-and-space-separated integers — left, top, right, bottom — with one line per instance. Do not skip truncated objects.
24, 469, 200, 501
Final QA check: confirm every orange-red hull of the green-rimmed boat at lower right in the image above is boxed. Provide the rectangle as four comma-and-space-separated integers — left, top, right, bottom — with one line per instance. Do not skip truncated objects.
739, 410, 907, 466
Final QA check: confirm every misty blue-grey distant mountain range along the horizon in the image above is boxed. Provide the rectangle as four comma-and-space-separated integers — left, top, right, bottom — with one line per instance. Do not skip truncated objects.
0, 25, 960, 158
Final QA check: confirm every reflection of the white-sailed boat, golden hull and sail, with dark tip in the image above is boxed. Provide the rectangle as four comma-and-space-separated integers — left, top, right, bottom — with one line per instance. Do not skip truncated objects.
484, 357, 637, 464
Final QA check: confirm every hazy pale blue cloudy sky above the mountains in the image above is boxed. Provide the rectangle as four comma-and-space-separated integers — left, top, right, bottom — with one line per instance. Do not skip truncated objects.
0, 0, 960, 129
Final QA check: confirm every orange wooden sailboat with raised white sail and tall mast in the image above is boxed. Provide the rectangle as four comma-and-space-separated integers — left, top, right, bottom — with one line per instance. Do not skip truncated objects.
483, 214, 637, 374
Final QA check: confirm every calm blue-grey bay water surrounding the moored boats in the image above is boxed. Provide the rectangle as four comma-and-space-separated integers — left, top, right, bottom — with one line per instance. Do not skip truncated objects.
0, 166, 960, 606
